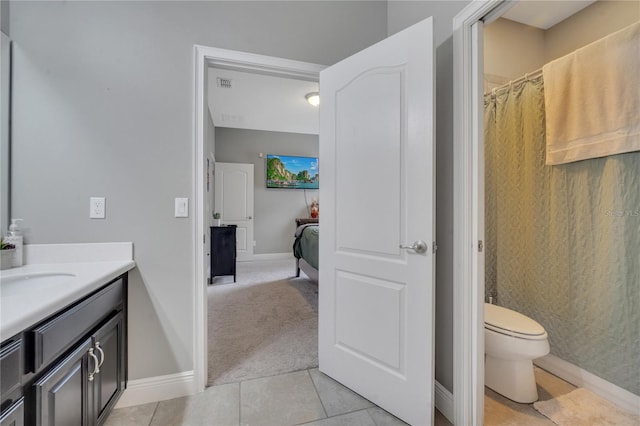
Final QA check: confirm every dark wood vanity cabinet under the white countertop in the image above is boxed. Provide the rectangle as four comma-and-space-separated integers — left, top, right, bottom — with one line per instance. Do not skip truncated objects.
0, 274, 127, 426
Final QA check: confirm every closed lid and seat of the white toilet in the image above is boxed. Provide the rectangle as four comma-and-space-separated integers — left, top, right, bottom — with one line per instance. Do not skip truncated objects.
484, 303, 547, 340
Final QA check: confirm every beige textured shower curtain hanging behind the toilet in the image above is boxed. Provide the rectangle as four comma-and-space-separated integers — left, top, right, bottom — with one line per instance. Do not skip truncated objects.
485, 77, 640, 395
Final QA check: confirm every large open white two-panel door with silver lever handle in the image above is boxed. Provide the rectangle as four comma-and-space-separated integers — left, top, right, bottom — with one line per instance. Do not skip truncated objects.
319, 18, 435, 425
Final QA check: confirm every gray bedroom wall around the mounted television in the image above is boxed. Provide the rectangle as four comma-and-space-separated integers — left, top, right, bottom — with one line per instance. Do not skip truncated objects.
216, 127, 322, 254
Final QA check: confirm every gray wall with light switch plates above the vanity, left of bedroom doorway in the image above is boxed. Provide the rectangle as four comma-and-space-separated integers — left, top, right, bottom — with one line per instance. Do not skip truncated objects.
10, 1, 387, 379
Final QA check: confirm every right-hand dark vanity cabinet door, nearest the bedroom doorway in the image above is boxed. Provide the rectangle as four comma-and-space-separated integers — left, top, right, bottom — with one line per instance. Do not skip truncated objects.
92, 313, 124, 425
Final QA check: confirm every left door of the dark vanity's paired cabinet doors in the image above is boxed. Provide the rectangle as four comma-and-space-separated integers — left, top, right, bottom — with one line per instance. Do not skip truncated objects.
32, 339, 97, 426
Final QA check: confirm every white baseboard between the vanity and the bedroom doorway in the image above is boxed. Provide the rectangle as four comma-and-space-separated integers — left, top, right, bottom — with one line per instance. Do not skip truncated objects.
116, 371, 196, 408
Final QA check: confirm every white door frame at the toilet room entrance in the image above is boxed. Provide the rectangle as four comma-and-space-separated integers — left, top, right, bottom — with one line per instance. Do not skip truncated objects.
453, 0, 517, 425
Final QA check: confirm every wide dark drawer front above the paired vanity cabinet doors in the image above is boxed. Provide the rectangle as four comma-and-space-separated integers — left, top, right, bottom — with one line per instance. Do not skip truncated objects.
32, 279, 123, 372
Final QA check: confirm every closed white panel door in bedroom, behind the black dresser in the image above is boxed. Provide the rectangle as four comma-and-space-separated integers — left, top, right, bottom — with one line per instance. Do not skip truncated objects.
215, 162, 254, 261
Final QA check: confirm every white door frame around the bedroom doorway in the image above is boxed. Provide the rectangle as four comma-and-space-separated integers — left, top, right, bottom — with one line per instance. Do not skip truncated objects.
191, 45, 325, 392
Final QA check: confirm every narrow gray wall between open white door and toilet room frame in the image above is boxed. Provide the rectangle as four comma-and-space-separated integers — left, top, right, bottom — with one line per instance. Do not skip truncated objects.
387, 1, 470, 392
